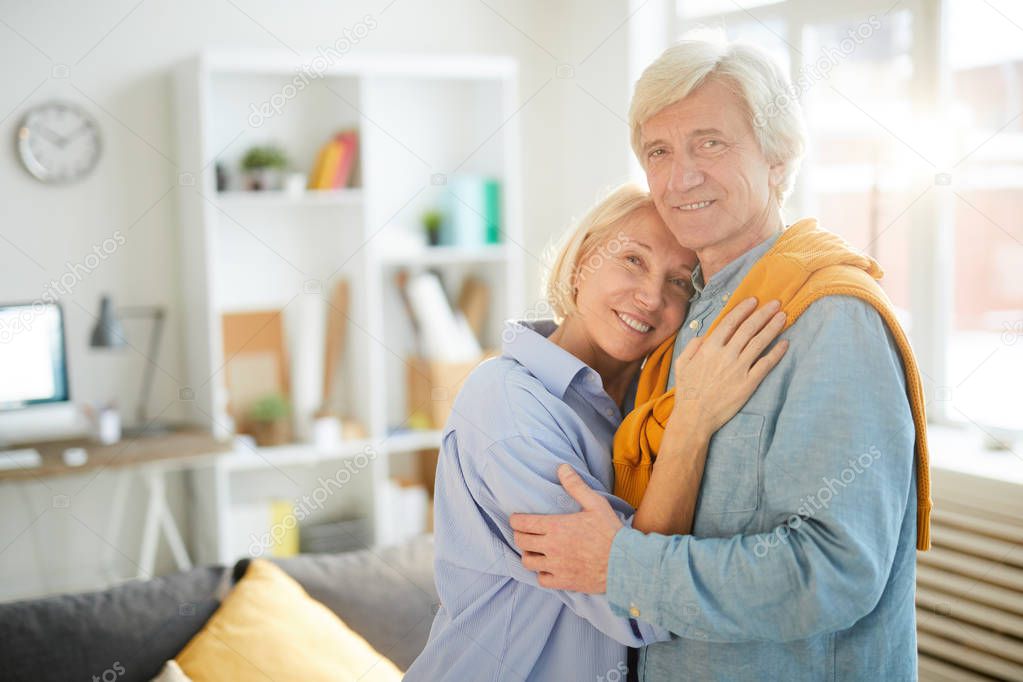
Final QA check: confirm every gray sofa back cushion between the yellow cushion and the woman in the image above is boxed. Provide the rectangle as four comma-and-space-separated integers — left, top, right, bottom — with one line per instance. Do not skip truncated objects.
268, 537, 438, 670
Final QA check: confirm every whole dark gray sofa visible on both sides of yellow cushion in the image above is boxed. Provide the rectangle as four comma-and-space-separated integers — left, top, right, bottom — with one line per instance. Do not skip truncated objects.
0, 537, 437, 682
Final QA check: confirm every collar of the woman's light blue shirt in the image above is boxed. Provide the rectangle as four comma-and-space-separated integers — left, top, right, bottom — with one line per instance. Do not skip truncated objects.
501, 320, 596, 398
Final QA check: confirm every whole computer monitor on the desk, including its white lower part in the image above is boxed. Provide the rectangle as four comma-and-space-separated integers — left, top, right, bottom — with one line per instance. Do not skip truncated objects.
0, 302, 87, 448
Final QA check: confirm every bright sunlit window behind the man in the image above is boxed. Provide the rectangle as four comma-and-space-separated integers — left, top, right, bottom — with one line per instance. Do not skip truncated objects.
671, 0, 1023, 433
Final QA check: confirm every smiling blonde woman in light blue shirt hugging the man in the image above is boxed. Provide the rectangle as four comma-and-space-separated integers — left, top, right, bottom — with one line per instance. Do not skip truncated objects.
406, 186, 786, 682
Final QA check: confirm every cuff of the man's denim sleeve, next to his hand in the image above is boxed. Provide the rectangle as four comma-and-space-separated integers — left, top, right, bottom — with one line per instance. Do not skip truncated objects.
607, 528, 669, 625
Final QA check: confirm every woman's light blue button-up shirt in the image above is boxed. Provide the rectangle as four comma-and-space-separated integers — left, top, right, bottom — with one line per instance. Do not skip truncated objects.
405, 321, 669, 682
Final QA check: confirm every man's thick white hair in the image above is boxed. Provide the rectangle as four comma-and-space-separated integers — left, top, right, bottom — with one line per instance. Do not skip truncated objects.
629, 36, 806, 206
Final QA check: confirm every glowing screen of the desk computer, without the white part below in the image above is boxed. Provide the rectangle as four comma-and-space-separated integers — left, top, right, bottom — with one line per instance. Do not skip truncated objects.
0, 303, 71, 410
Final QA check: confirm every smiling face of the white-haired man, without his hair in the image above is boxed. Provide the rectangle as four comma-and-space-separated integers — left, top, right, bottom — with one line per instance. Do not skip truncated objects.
640, 80, 783, 260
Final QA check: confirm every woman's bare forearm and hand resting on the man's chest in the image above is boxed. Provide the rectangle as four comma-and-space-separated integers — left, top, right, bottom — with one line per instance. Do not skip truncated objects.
632, 299, 788, 535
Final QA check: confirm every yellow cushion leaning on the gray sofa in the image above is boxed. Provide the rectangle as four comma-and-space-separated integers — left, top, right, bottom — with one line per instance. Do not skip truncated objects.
175, 559, 401, 682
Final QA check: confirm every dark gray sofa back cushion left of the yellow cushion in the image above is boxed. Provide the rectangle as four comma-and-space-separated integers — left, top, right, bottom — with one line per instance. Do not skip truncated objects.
0, 566, 227, 682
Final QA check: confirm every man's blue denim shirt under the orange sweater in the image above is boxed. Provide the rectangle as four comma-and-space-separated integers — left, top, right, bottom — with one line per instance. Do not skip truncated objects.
607, 236, 917, 682
